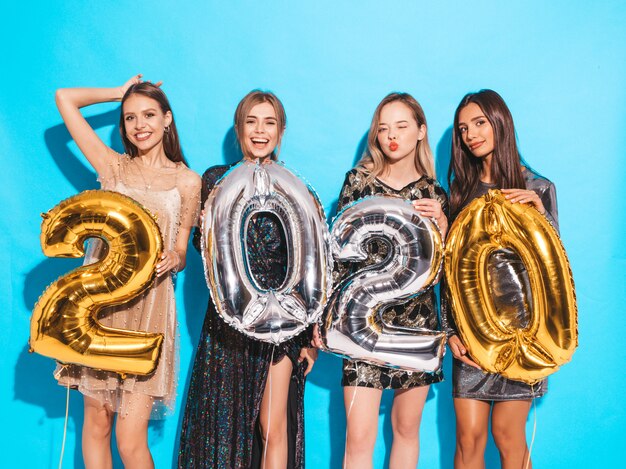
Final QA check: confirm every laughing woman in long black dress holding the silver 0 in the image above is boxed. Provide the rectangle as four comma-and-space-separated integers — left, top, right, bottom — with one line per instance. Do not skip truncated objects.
178, 91, 317, 469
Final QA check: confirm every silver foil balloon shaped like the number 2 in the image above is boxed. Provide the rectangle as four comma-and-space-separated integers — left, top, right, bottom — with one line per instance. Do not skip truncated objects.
320, 196, 446, 372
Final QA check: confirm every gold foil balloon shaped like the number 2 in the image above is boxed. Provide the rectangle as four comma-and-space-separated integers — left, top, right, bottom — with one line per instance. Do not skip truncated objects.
30, 190, 163, 375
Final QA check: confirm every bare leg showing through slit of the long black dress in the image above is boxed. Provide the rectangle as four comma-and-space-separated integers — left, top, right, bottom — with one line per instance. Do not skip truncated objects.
259, 357, 293, 469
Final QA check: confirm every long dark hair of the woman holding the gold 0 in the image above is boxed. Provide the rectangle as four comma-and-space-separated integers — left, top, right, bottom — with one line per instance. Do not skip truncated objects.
448, 90, 526, 216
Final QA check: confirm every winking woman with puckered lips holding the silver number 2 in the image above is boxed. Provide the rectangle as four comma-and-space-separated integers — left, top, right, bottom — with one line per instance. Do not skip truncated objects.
320, 93, 448, 469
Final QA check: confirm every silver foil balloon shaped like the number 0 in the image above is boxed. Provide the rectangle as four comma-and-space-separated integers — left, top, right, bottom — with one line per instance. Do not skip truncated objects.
201, 161, 331, 344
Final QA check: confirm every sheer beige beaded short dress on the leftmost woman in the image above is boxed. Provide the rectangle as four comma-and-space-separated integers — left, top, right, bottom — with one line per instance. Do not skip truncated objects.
55, 155, 201, 419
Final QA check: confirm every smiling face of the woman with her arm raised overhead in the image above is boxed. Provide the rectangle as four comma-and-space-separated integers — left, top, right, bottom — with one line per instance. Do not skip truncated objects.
122, 94, 172, 154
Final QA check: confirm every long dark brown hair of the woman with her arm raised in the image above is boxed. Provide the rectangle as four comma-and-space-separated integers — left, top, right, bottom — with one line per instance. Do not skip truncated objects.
120, 81, 189, 166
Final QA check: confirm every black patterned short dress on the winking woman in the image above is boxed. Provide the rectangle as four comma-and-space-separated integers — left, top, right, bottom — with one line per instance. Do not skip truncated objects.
333, 168, 448, 389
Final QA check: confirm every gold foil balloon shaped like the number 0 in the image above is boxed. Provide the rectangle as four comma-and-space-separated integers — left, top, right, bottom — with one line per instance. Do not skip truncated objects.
444, 190, 578, 384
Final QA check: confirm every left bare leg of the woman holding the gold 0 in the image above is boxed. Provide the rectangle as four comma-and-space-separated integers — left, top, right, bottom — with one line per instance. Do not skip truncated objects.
454, 398, 491, 469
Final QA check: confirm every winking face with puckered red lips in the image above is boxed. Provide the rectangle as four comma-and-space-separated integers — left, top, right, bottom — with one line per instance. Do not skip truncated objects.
377, 101, 426, 161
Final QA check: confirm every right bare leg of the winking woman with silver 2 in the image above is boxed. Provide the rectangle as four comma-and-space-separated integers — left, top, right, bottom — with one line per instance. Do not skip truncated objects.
389, 386, 429, 469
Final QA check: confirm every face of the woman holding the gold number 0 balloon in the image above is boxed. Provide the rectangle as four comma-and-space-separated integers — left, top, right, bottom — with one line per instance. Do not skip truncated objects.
458, 103, 495, 158
